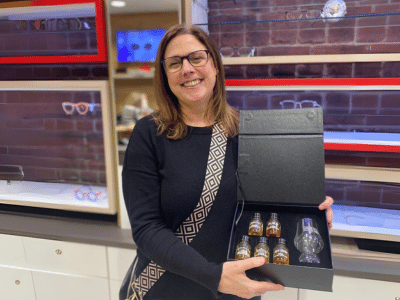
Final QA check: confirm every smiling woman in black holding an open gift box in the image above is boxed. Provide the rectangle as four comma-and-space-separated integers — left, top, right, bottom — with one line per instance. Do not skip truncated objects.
120, 25, 333, 300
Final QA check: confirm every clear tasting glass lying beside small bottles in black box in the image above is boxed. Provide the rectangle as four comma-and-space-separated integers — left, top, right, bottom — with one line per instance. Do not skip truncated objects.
294, 218, 324, 264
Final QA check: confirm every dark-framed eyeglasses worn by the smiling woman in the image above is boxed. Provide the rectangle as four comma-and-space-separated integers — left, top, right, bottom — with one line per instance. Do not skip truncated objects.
161, 50, 210, 73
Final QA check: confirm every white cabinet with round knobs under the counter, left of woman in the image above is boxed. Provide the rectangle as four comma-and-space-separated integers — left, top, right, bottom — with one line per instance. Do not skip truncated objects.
0, 234, 137, 300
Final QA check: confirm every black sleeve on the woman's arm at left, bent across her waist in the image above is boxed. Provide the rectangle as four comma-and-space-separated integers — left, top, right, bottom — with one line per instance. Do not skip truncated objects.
122, 117, 222, 296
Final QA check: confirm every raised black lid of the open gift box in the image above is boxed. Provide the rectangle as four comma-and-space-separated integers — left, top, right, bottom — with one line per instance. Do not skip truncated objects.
238, 108, 325, 205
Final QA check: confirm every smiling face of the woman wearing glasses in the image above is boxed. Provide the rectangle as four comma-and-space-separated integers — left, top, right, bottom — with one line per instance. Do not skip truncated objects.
164, 34, 217, 108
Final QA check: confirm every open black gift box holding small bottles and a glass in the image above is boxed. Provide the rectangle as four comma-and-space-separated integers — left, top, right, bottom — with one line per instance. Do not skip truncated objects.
228, 108, 333, 291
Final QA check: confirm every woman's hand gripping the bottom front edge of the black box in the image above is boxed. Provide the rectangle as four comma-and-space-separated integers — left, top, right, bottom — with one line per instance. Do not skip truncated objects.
218, 257, 284, 299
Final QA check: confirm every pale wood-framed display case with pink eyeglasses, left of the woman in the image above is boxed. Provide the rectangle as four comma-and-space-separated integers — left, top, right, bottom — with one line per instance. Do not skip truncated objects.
0, 81, 118, 215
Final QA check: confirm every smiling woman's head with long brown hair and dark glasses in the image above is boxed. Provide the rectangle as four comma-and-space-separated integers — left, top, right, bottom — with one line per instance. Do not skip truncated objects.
149, 25, 238, 139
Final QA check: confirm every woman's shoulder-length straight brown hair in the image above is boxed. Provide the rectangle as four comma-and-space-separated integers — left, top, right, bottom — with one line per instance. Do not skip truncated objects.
153, 24, 239, 140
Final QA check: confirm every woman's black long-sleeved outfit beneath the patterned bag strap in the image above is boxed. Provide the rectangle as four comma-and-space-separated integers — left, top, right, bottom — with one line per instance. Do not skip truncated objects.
122, 116, 260, 300
